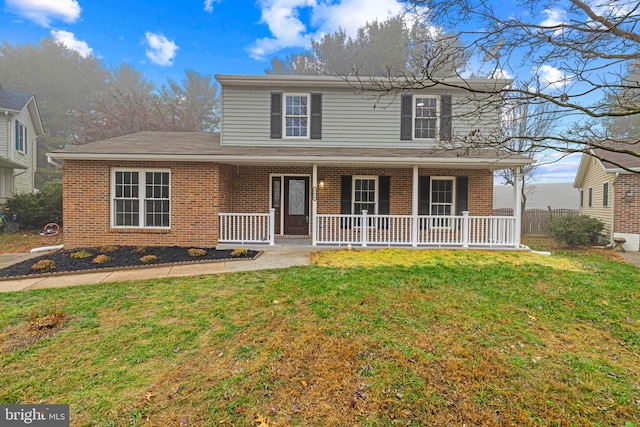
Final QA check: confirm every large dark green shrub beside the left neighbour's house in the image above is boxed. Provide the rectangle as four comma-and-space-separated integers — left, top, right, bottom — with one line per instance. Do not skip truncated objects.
7, 180, 62, 229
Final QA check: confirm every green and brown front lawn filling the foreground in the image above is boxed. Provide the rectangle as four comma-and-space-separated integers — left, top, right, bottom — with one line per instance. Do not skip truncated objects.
0, 250, 640, 427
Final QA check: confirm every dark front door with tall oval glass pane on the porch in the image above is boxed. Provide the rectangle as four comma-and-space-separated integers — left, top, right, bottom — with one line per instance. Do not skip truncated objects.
282, 176, 309, 235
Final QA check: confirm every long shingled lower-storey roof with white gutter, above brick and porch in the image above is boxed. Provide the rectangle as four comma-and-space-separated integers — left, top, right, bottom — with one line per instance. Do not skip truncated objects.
47, 131, 533, 170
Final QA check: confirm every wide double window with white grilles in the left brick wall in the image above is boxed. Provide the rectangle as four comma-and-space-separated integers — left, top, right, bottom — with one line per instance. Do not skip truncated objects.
111, 169, 171, 228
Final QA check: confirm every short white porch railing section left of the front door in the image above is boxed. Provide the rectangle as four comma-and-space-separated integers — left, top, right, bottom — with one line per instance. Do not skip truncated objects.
218, 209, 275, 245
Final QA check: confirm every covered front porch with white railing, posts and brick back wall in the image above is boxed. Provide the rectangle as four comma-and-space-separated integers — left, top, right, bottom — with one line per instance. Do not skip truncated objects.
218, 164, 521, 249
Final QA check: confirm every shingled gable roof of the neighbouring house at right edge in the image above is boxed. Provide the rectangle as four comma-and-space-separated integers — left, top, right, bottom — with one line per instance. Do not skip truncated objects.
573, 139, 640, 188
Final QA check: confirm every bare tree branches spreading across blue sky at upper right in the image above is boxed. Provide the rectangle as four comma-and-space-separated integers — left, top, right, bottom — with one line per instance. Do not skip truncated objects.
363, 0, 640, 166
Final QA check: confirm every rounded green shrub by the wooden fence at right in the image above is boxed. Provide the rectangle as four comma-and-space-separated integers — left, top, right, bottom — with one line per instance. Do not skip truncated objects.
549, 215, 604, 247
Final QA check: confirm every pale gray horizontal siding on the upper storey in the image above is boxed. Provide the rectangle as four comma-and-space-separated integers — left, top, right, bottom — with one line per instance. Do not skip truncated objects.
221, 87, 499, 147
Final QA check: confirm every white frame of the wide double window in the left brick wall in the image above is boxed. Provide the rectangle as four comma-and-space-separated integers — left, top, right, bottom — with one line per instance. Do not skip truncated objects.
109, 168, 172, 229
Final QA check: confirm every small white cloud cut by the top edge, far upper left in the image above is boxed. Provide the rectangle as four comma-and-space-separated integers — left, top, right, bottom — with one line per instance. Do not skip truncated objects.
5, 0, 82, 27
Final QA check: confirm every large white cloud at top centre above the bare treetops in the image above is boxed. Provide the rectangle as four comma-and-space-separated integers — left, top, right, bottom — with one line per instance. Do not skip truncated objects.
248, 0, 403, 60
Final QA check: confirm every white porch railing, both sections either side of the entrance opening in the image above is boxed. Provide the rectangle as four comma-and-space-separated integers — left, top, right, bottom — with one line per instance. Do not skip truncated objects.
219, 209, 518, 248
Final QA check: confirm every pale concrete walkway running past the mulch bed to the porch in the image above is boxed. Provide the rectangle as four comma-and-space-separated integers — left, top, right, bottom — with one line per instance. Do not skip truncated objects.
0, 245, 320, 292
